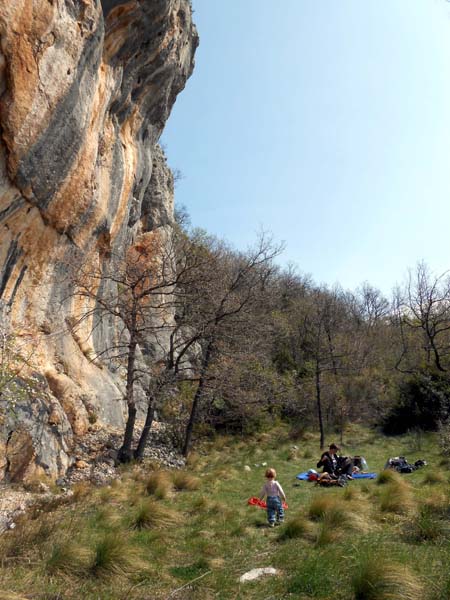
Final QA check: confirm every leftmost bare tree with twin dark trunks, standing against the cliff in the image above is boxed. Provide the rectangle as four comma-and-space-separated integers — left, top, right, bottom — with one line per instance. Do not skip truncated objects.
71, 228, 213, 462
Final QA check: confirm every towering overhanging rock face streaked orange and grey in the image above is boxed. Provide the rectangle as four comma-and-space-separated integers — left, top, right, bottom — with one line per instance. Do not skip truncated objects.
0, 0, 198, 480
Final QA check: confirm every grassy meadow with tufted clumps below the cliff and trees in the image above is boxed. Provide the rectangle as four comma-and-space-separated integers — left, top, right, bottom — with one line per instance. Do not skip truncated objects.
0, 426, 450, 600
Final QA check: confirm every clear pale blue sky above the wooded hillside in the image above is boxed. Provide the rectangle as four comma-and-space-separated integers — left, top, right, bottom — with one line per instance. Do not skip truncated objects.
162, 0, 450, 294
